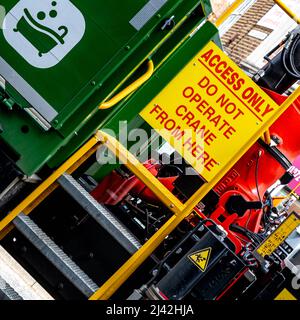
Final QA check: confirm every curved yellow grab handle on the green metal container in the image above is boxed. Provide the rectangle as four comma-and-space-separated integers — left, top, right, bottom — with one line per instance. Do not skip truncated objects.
99, 60, 154, 110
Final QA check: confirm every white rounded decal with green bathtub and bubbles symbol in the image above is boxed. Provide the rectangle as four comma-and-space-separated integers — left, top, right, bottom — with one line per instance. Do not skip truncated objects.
3, 0, 86, 68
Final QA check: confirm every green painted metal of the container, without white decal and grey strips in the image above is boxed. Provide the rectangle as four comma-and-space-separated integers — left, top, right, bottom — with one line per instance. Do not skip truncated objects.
0, 0, 216, 175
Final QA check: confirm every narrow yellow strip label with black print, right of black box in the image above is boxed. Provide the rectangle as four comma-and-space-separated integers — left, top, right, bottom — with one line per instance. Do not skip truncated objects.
256, 213, 300, 257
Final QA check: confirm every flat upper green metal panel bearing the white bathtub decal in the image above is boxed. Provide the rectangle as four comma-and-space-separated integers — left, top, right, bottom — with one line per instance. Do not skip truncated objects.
0, 0, 203, 125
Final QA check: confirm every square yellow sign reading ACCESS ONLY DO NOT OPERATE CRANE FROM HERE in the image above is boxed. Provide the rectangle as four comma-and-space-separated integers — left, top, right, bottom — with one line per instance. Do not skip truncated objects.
140, 42, 279, 181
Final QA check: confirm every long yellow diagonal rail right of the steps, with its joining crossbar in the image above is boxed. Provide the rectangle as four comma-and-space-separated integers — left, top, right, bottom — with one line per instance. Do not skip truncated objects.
90, 88, 300, 300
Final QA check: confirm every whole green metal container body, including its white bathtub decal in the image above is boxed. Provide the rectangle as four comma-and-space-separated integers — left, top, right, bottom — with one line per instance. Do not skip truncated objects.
0, 0, 213, 174
